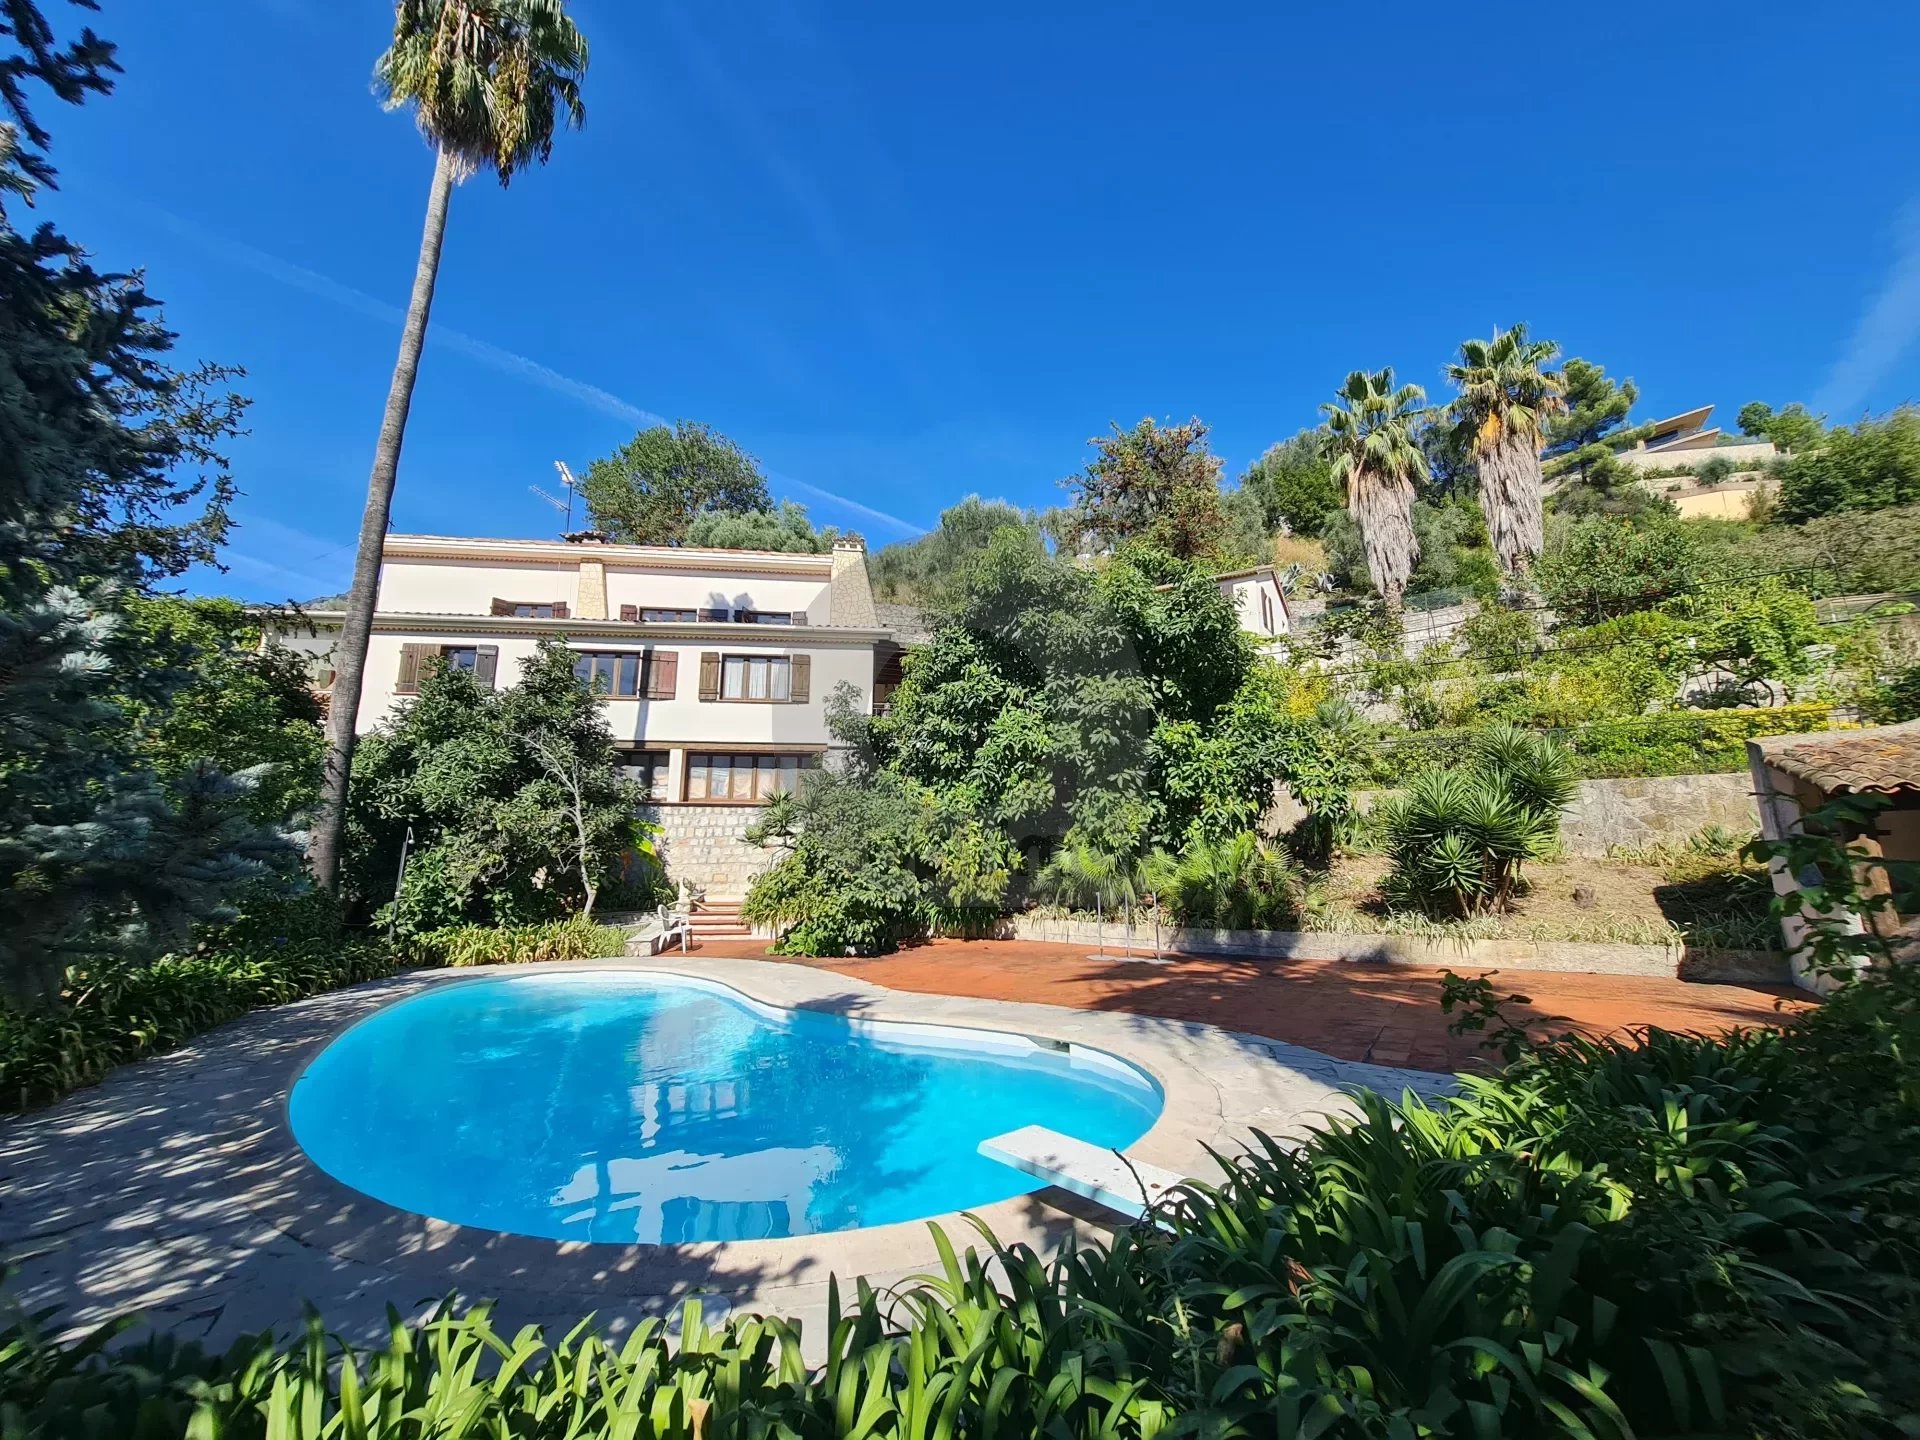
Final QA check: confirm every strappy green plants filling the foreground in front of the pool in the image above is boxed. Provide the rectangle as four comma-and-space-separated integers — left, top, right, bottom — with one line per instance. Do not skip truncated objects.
0, 968, 1920, 1440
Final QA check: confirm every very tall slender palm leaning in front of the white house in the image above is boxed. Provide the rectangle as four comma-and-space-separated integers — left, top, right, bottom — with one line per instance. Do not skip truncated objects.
307, 0, 588, 889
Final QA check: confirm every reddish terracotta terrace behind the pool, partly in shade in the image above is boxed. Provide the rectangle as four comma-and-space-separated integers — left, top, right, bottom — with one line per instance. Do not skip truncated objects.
687, 941, 1811, 1073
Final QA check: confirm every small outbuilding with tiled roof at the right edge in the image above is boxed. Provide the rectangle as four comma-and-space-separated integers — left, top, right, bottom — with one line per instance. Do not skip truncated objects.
1747, 720, 1920, 989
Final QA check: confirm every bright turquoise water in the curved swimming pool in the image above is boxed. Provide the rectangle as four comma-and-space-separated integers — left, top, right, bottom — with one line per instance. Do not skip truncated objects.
288, 972, 1160, 1242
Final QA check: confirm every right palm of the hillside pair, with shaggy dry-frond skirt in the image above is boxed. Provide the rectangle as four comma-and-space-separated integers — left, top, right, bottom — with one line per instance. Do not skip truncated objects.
1446, 324, 1567, 578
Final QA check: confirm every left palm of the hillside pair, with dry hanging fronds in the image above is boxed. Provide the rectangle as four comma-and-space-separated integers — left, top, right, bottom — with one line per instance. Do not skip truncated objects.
1321, 365, 1427, 611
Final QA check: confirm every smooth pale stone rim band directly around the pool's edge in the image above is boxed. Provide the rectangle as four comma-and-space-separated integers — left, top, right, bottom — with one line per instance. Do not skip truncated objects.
240, 958, 1225, 1298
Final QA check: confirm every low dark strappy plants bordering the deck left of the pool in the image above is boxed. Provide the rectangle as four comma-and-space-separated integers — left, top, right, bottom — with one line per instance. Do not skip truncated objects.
0, 895, 394, 1110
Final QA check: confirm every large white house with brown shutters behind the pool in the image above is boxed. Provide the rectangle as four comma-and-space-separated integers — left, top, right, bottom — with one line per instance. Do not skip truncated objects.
282, 536, 899, 897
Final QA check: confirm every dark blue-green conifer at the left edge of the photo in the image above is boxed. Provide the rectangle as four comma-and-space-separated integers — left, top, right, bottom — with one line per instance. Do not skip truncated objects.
0, 0, 294, 998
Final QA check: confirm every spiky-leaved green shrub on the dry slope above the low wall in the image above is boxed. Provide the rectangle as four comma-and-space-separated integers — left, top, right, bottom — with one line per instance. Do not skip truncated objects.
1379, 726, 1574, 916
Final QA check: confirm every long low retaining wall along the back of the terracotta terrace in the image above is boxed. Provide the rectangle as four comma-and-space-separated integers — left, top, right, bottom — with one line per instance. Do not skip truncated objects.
1000, 916, 1788, 983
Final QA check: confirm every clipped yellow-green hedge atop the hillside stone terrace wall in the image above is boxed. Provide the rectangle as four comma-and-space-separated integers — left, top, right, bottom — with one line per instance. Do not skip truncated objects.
1369, 705, 1834, 785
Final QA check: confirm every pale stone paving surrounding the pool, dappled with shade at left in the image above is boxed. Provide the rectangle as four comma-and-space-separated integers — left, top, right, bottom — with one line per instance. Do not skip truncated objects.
0, 950, 1446, 1344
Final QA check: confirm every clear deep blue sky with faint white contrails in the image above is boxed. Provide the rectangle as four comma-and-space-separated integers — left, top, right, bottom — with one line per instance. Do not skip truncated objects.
42, 0, 1920, 599
